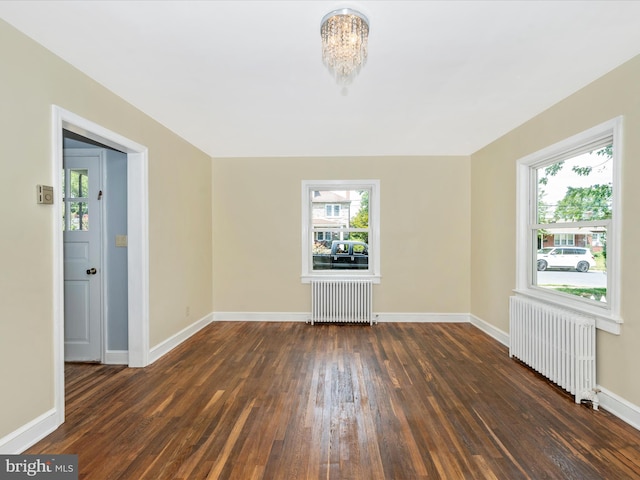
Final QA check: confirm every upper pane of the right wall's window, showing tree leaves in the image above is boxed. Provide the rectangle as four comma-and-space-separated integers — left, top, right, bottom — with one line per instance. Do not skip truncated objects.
536, 145, 613, 224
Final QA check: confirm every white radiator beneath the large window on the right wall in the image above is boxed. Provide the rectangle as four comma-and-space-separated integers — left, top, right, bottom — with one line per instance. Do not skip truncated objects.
509, 297, 598, 410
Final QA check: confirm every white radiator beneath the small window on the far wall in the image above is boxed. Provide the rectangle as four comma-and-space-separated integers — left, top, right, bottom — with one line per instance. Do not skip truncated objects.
311, 279, 373, 325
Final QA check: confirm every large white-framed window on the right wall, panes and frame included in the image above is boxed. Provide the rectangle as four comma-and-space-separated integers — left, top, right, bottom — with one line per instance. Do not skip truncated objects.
517, 119, 621, 333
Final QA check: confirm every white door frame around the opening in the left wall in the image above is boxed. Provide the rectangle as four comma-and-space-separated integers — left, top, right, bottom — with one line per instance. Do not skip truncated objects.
51, 105, 149, 424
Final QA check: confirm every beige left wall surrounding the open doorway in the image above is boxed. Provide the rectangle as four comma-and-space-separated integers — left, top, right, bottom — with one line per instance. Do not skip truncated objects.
0, 20, 212, 438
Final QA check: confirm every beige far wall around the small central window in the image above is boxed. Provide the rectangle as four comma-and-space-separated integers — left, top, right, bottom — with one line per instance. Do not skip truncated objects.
213, 157, 470, 313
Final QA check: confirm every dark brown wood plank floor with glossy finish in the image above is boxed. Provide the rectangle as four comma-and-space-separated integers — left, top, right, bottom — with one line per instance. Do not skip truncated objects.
26, 322, 640, 480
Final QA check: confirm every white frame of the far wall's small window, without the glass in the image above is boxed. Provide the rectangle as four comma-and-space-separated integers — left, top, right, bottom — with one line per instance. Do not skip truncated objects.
300, 179, 381, 283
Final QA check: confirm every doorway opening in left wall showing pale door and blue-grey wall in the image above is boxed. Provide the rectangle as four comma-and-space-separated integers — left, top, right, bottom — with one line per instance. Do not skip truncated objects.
61, 130, 128, 365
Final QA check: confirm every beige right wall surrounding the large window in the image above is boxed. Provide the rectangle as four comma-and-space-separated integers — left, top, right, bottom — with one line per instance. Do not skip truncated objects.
471, 53, 640, 405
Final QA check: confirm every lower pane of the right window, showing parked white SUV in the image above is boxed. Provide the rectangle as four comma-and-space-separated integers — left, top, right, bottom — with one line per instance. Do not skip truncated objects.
533, 227, 607, 302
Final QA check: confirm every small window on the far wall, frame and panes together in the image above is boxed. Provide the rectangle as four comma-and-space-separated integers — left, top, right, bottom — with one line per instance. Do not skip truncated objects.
302, 180, 380, 282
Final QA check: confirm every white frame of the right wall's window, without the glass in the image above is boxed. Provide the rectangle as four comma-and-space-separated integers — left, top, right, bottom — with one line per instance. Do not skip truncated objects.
514, 116, 623, 334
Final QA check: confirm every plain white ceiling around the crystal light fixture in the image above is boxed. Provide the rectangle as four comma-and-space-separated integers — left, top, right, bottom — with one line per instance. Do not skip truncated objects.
0, 0, 640, 157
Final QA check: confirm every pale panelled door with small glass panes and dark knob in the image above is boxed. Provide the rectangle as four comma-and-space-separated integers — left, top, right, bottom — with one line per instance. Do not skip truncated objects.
63, 149, 104, 362
